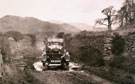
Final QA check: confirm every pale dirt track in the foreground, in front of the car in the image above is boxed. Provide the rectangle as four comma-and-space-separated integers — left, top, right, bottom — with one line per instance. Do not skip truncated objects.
30, 70, 113, 84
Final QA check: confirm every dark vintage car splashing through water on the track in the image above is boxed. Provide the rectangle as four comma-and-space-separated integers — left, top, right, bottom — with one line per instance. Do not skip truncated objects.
42, 39, 70, 70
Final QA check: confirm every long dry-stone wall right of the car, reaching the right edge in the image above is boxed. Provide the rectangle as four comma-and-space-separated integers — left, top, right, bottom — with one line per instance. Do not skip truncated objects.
68, 31, 135, 60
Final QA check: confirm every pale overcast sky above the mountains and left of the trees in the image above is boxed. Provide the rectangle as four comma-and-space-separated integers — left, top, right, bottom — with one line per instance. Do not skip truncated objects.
0, 0, 124, 25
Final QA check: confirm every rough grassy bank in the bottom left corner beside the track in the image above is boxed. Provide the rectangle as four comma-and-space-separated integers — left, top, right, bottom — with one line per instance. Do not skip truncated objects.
0, 64, 43, 84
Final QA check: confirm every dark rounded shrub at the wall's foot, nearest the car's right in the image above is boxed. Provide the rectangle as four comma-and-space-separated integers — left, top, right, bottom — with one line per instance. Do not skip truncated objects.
79, 46, 103, 66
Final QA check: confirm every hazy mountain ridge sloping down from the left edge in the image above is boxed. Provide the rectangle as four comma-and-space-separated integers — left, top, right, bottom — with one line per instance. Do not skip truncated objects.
0, 15, 80, 33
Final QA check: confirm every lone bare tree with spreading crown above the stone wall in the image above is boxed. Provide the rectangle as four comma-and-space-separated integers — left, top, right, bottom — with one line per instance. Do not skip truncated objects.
96, 6, 116, 31
